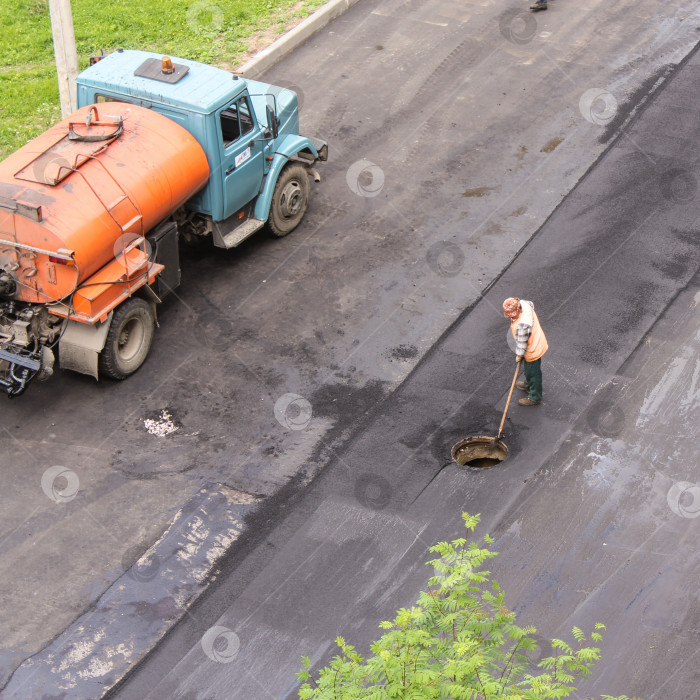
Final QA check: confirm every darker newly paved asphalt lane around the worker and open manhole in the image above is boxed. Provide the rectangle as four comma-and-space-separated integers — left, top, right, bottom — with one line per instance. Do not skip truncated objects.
110, 30, 700, 700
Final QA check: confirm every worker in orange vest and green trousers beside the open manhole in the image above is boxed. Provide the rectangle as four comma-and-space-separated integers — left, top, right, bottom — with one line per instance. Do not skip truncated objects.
503, 297, 549, 406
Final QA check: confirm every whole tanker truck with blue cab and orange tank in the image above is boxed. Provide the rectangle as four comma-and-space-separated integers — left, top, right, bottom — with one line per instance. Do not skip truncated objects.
0, 50, 327, 397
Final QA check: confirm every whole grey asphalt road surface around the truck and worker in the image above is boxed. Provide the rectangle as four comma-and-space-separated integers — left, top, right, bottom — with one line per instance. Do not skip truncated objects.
0, 0, 700, 700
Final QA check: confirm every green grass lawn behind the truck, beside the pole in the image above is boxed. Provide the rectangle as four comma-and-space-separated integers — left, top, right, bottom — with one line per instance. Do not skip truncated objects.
0, 0, 325, 160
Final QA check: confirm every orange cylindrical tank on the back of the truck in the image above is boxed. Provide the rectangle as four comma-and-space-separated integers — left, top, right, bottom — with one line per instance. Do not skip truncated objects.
0, 102, 209, 304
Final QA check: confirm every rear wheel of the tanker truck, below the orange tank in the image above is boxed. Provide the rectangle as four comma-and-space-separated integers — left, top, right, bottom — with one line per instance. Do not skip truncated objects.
99, 297, 156, 379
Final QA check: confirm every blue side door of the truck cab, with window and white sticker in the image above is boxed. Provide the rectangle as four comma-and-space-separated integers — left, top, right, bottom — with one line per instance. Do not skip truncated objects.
219, 95, 265, 219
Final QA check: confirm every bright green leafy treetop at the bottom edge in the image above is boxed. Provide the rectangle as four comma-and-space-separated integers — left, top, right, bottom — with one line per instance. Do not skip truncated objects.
297, 513, 629, 700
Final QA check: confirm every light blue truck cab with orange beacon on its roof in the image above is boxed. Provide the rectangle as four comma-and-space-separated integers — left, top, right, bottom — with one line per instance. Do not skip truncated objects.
76, 49, 328, 248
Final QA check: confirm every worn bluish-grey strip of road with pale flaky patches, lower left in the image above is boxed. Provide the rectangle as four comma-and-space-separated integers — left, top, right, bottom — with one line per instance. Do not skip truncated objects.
2, 484, 258, 700
